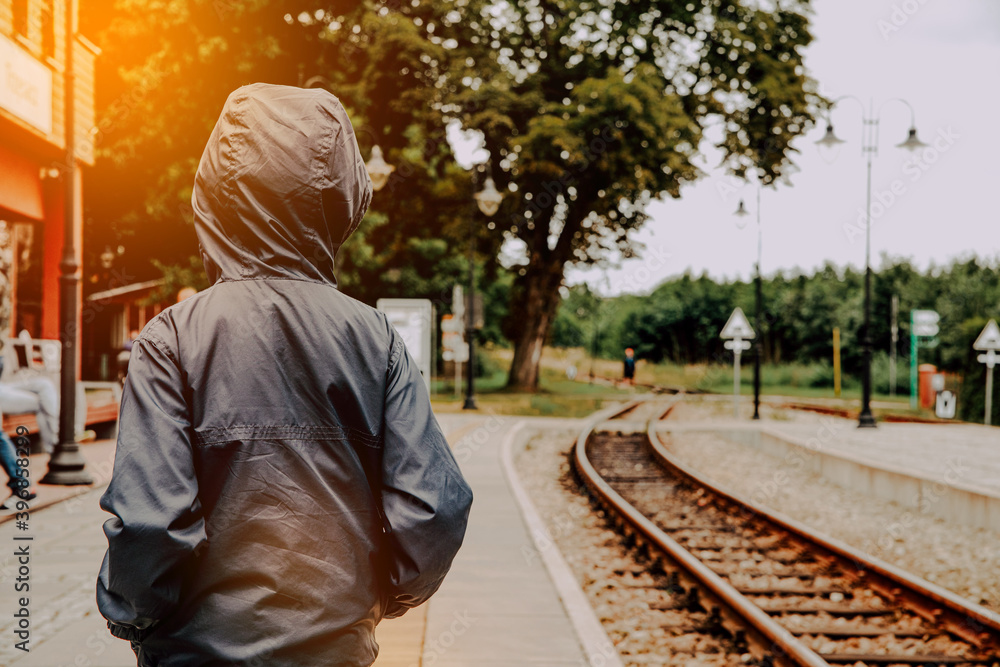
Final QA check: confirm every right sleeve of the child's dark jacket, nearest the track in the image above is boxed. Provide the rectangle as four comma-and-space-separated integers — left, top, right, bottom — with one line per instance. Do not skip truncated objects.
382, 331, 472, 618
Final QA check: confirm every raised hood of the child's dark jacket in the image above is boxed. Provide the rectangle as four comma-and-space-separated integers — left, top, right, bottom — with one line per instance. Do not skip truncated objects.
191, 83, 372, 285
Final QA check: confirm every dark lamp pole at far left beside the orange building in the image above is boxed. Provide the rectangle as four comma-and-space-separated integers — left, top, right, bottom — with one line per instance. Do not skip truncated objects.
40, 0, 94, 486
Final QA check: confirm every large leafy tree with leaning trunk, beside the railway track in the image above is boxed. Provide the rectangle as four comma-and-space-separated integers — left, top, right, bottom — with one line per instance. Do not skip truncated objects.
436, 0, 820, 390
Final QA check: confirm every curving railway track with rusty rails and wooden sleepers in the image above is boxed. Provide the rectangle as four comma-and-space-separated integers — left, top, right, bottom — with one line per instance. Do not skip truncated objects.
572, 398, 1000, 667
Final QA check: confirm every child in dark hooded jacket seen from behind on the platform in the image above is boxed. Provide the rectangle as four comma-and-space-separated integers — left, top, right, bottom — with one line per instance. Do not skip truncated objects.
98, 85, 471, 666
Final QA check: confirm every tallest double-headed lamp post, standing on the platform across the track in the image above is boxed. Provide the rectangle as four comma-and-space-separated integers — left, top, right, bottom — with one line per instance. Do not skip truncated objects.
816, 95, 927, 428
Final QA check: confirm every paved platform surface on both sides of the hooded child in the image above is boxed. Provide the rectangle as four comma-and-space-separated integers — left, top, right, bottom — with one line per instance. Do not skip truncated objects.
0, 414, 587, 667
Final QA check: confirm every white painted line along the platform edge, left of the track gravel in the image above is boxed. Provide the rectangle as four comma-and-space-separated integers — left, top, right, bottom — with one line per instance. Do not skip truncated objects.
501, 421, 622, 667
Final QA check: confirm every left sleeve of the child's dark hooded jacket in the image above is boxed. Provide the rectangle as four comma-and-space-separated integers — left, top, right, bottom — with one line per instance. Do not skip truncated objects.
97, 336, 206, 640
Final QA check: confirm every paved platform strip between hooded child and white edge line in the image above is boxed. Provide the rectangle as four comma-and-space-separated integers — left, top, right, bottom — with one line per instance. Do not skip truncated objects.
375, 415, 616, 667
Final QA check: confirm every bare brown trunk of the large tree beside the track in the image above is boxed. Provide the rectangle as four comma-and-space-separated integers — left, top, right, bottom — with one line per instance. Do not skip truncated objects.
507, 256, 563, 392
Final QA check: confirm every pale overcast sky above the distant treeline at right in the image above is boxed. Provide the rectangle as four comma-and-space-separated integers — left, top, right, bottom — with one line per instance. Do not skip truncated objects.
567, 0, 1000, 294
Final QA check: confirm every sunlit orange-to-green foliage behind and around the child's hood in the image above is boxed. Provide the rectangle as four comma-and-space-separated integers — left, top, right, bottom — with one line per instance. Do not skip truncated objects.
86, 0, 502, 324
